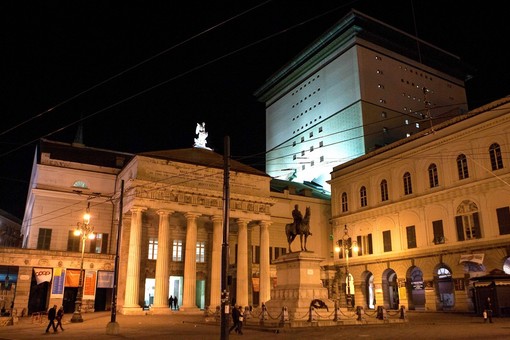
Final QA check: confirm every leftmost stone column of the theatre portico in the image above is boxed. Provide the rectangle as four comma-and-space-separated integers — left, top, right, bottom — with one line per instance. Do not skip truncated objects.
124, 207, 146, 314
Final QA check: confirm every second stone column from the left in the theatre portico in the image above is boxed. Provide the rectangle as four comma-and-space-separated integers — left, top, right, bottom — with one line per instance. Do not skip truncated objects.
151, 210, 172, 312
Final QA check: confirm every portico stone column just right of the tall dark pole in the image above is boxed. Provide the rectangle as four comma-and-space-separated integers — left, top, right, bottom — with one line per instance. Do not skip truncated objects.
236, 219, 249, 307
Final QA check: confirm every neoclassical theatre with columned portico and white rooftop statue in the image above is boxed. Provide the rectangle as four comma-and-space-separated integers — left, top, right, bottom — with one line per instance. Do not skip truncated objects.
12, 136, 331, 314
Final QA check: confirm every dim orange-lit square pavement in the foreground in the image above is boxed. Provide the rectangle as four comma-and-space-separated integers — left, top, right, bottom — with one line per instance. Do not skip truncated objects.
0, 312, 510, 340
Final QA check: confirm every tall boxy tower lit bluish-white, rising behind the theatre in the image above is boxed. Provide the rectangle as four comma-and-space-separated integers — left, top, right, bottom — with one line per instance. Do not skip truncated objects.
255, 11, 467, 191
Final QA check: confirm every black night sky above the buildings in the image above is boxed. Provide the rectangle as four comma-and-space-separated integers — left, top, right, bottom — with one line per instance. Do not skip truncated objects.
0, 0, 510, 218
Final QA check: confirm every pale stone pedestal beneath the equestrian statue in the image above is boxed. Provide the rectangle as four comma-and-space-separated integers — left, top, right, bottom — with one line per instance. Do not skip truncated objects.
265, 251, 335, 327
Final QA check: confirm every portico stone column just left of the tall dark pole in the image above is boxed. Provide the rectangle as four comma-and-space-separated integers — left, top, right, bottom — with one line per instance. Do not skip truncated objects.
209, 216, 223, 311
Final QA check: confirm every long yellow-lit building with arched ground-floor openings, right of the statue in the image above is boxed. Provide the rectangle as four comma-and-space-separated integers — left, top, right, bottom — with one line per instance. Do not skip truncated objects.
331, 98, 510, 314
